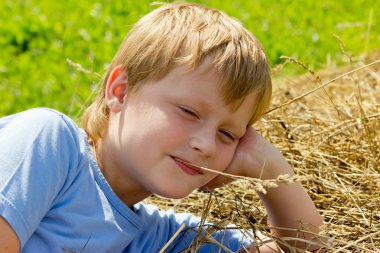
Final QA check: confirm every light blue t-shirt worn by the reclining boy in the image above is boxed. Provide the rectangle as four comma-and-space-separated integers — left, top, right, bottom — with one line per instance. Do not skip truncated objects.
0, 109, 249, 253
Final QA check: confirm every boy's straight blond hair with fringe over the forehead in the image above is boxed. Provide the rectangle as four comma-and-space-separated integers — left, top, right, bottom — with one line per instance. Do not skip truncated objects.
83, 3, 272, 142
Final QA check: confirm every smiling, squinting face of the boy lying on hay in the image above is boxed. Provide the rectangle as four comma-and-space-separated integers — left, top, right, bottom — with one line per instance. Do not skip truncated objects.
105, 62, 255, 203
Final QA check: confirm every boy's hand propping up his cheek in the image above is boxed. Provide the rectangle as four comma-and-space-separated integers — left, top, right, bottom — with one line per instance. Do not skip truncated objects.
201, 127, 293, 189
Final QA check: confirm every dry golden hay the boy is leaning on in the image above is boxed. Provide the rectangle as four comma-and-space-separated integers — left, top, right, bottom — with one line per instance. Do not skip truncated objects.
144, 56, 380, 252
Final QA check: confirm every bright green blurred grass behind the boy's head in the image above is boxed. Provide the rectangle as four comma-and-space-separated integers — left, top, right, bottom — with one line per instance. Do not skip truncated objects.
0, 0, 380, 117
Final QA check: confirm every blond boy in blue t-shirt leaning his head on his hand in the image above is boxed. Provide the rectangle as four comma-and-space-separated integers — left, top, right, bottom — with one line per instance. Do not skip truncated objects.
0, 1, 322, 252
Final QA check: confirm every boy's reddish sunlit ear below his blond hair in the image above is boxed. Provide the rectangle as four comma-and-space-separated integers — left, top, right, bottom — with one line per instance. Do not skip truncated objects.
105, 66, 128, 113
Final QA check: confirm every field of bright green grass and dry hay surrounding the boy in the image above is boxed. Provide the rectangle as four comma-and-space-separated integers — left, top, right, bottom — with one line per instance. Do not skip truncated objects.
0, 0, 380, 252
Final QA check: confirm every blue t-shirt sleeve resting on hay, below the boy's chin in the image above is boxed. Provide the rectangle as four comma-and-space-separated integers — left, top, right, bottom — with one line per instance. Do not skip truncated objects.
127, 204, 252, 253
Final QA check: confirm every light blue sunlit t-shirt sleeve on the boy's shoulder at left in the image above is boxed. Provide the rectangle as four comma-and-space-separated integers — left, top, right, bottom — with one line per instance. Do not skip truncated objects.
0, 109, 80, 247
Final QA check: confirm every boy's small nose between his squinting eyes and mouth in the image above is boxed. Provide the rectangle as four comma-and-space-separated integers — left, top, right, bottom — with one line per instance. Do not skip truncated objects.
189, 129, 216, 157
